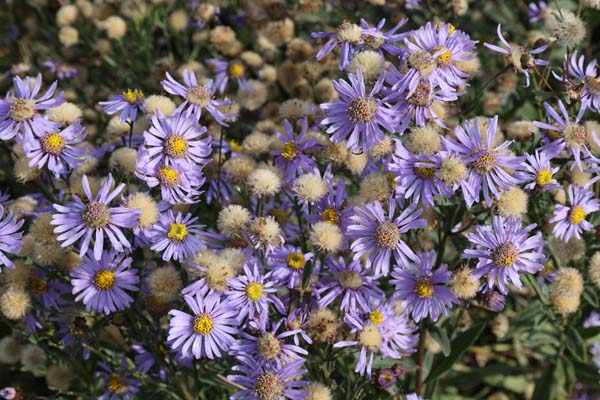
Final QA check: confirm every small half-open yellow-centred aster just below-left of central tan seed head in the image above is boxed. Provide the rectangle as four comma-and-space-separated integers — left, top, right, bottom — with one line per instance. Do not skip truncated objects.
269, 246, 314, 289
